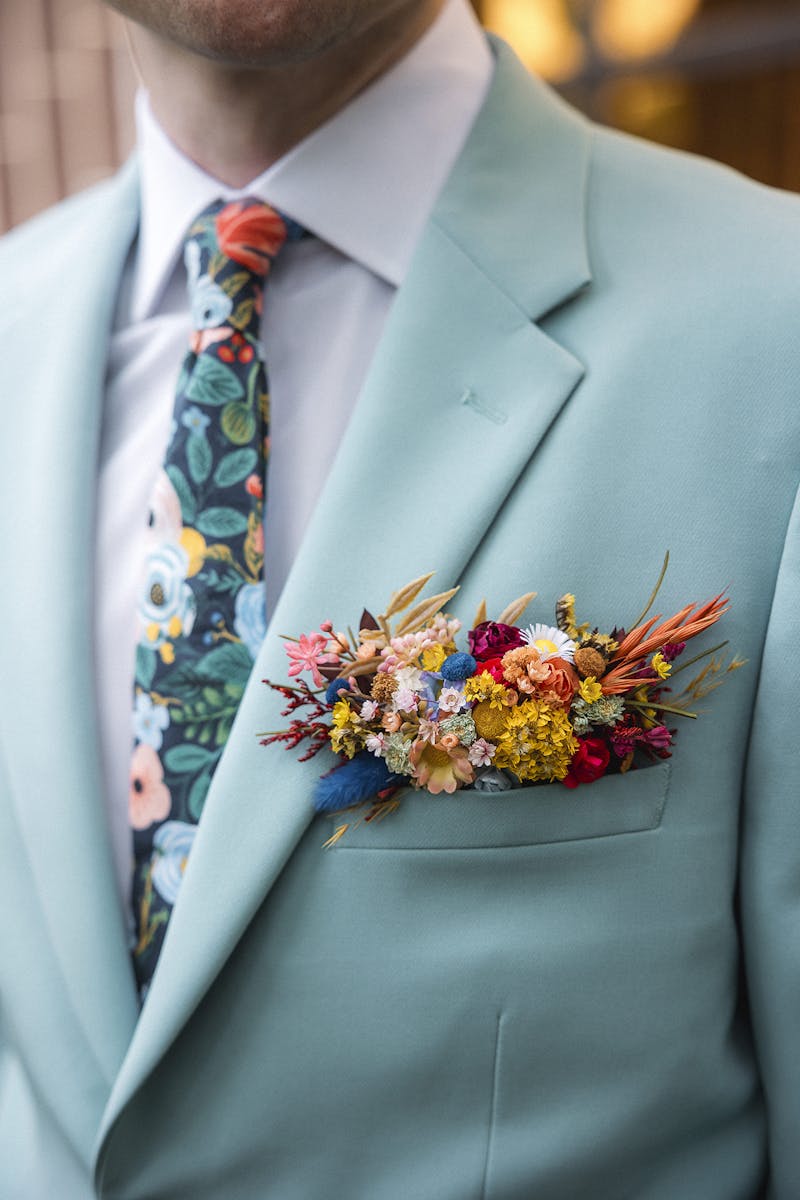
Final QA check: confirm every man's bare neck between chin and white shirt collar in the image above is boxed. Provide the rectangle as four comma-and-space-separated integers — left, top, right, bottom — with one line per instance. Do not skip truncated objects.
130, 0, 443, 187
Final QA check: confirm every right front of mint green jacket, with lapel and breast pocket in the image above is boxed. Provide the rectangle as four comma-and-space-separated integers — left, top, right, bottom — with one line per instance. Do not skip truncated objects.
1, 37, 798, 1200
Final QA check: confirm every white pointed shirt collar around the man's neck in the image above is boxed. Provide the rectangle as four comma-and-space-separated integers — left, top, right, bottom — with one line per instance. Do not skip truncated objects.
132, 0, 492, 320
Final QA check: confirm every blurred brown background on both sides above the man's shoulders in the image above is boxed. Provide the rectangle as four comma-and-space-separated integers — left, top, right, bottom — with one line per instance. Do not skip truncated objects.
0, 0, 800, 229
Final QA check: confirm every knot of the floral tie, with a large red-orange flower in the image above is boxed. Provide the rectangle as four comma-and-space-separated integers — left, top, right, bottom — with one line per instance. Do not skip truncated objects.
184, 197, 299, 334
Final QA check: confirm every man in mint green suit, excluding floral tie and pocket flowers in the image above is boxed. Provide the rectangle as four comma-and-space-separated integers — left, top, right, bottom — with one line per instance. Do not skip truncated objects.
0, 0, 800, 1200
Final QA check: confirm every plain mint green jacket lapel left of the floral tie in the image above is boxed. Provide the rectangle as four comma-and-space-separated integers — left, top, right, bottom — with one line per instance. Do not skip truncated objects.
0, 170, 137, 1099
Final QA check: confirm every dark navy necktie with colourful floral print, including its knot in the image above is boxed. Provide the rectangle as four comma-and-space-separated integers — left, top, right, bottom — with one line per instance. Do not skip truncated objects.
130, 199, 301, 995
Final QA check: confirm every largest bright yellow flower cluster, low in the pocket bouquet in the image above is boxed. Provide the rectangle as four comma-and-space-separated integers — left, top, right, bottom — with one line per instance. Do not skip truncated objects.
494, 698, 578, 782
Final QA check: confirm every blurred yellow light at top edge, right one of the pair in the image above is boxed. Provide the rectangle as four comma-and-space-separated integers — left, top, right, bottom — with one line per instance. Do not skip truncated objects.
594, 0, 700, 59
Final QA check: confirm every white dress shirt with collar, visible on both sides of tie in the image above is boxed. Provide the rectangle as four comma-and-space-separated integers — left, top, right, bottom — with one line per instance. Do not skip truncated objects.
96, 0, 492, 907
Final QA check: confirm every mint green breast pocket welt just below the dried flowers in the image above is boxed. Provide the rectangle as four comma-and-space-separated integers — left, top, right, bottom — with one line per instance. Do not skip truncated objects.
333, 761, 670, 852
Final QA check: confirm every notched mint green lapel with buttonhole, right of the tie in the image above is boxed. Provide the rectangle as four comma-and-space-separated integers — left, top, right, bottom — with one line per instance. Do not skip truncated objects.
100, 48, 589, 1150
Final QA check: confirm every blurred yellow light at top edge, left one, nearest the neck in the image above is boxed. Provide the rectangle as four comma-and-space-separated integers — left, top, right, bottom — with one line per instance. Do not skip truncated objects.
482, 0, 587, 83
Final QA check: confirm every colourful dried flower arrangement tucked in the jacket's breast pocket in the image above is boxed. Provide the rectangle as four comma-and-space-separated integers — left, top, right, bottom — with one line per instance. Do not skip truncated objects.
259, 556, 744, 836
